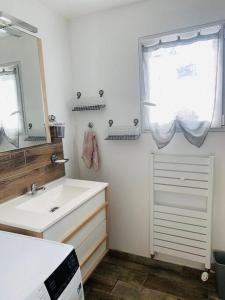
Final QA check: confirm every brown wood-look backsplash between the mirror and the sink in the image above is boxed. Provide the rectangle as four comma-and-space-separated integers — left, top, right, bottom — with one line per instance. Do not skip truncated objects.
0, 141, 65, 203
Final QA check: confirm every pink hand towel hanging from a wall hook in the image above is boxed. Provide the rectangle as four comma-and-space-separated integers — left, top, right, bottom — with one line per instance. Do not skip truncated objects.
82, 130, 99, 171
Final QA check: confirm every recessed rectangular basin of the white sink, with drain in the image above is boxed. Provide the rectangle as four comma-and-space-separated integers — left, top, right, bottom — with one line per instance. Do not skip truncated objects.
15, 182, 89, 214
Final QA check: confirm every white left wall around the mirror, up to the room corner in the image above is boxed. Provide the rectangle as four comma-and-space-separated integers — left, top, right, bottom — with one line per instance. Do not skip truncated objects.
0, 0, 79, 177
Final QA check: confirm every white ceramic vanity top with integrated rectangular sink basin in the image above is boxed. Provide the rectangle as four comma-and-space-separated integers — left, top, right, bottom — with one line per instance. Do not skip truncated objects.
0, 177, 108, 232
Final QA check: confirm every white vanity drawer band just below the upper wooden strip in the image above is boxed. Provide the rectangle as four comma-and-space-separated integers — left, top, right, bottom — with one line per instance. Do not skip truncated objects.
66, 208, 106, 249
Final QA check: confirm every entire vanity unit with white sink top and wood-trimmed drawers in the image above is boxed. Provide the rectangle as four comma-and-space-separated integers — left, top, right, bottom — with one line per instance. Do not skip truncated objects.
0, 178, 109, 282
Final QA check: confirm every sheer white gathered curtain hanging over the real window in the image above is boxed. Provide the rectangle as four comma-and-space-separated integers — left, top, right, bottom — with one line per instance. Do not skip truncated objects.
142, 26, 223, 148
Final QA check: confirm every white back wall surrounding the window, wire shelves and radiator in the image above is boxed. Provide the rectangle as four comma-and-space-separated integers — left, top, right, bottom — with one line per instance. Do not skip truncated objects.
70, 0, 225, 268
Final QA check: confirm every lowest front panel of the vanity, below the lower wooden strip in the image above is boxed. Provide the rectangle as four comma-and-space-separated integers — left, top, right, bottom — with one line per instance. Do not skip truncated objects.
81, 241, 107, 283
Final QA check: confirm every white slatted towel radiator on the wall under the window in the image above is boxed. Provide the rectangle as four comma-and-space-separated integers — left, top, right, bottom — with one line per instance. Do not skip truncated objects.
150, 154, 214, 281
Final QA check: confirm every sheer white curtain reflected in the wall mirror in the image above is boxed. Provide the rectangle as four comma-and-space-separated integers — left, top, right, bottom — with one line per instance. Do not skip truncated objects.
0, 71, 20, 147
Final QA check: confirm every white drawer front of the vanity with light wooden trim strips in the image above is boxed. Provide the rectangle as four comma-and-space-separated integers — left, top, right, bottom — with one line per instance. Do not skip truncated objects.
43, 189, 108, 282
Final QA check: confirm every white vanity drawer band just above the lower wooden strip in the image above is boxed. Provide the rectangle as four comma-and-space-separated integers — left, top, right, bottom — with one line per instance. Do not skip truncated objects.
76, 220, 106, 266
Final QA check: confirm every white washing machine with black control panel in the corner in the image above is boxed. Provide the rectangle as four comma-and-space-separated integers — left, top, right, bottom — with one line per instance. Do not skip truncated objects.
0, 231, 84, 300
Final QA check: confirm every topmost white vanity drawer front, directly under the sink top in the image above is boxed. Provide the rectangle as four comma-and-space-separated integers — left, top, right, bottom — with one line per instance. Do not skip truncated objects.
43, 191, 105, 242
